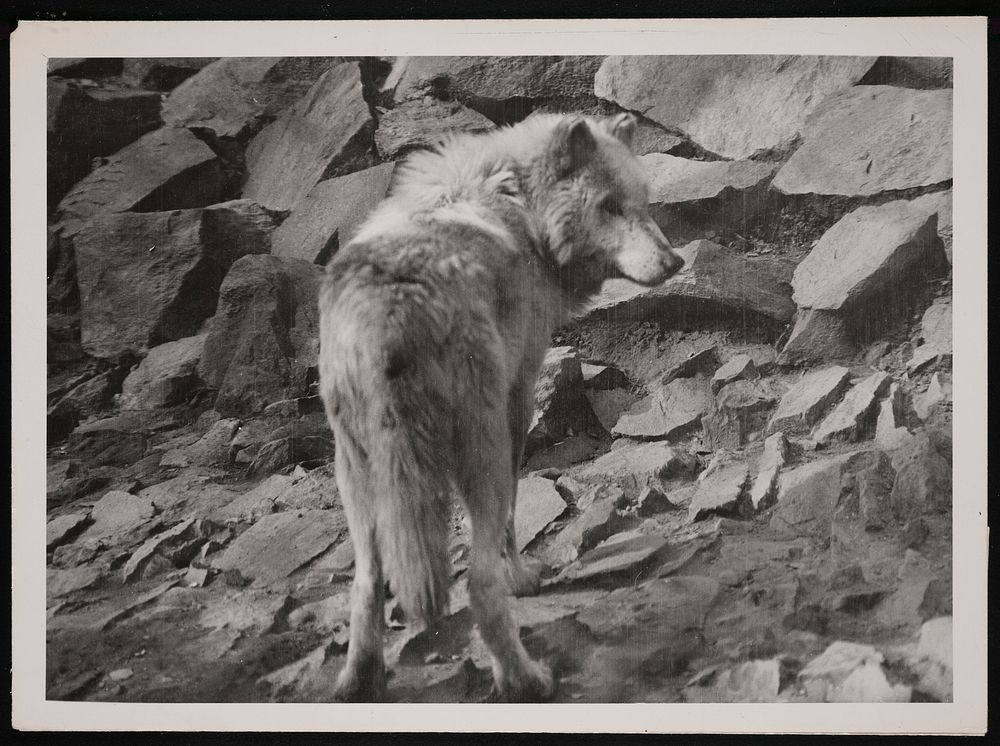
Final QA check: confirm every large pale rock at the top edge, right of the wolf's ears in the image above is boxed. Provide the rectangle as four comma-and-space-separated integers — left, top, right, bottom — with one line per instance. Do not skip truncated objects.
594, 55, 875, 159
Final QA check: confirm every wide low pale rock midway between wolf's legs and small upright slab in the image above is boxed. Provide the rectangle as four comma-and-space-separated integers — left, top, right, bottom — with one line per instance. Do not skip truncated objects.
574, 442, 696, 494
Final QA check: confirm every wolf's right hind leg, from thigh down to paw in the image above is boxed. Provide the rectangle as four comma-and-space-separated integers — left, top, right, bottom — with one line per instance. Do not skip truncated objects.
462, 428, 555, 702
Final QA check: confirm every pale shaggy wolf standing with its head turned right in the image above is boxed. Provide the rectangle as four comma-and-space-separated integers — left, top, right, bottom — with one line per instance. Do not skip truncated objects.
319, 113, 683, 702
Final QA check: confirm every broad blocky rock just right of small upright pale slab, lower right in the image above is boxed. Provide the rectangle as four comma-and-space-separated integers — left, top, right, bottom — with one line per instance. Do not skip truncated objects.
770, 451, 892, 537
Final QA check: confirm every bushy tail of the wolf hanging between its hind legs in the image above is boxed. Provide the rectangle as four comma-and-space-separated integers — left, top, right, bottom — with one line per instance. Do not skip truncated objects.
371, 423, 450, 625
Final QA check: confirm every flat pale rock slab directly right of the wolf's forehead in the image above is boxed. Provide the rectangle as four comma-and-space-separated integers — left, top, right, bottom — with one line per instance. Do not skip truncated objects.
639, 153, 777, 206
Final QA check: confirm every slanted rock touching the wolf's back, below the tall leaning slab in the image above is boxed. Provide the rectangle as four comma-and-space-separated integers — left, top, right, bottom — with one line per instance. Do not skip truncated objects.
273, 163, 395, 265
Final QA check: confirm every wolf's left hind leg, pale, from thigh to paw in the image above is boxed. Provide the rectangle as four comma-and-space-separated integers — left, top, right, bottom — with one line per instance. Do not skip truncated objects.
334, 433, 386, 702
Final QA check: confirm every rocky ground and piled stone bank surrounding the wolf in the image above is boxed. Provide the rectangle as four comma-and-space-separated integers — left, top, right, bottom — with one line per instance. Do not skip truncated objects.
46, 57, 961, 702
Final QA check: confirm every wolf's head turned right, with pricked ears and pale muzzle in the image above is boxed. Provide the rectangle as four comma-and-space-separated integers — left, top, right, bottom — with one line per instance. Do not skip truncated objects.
532, 114, 684, 295
